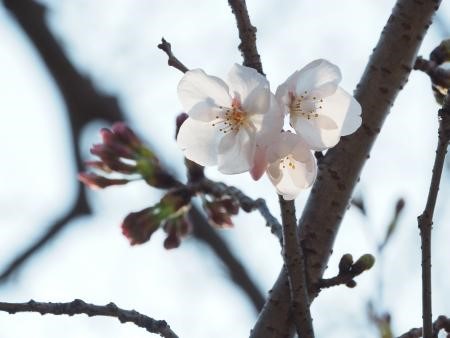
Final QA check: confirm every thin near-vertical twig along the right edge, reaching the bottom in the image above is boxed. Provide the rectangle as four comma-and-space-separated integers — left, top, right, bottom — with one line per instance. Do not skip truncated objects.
417, 94, 450, 338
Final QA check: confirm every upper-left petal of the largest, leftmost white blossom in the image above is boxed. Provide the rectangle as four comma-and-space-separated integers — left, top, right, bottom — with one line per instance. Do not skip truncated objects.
178, 69, 231, 114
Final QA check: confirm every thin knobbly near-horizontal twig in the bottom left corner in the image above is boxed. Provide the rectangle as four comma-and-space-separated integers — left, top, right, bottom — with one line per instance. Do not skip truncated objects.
0, 299, 178, 338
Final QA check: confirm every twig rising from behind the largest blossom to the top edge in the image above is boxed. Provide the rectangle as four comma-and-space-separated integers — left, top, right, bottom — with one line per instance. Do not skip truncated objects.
228, 0, 264, 75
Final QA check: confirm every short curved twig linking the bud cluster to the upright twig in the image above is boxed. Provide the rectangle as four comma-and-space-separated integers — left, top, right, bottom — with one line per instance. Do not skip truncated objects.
200, 179, 283, 245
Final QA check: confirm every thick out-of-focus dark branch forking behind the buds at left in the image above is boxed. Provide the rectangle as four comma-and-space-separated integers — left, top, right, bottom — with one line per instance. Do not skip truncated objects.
0, 0, 264, 311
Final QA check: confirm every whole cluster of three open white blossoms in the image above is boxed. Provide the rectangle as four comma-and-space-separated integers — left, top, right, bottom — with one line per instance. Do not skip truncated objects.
177, 59, 361, 200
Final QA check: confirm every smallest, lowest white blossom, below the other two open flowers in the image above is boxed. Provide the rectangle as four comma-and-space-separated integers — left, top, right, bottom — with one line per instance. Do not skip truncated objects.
267, 132, 317, 200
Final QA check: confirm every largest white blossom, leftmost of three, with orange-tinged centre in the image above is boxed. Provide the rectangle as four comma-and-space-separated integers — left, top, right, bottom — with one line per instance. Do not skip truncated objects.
177, 64, 283, 179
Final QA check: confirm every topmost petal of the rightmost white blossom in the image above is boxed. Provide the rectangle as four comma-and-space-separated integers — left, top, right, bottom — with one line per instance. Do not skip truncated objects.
296, 59, 342, 97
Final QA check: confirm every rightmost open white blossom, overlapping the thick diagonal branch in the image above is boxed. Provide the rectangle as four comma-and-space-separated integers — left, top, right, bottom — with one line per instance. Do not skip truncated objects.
276, 59, 361, 150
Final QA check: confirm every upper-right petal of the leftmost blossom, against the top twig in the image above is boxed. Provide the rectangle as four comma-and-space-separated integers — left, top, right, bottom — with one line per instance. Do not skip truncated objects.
228, 63, 270, 104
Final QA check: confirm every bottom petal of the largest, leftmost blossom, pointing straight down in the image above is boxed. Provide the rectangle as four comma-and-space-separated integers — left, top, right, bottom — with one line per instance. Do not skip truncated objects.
218, 128, 256, 174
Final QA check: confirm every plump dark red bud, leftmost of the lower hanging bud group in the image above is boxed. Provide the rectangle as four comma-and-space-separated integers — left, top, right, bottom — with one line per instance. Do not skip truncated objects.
121, 207, 161, 245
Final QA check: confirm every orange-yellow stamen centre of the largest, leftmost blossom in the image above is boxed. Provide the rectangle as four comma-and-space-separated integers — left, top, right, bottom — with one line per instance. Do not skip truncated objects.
212, 99, 251, 134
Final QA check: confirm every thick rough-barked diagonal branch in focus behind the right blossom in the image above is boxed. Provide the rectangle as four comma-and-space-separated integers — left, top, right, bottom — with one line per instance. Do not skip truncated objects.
251, 0, 440, 338
